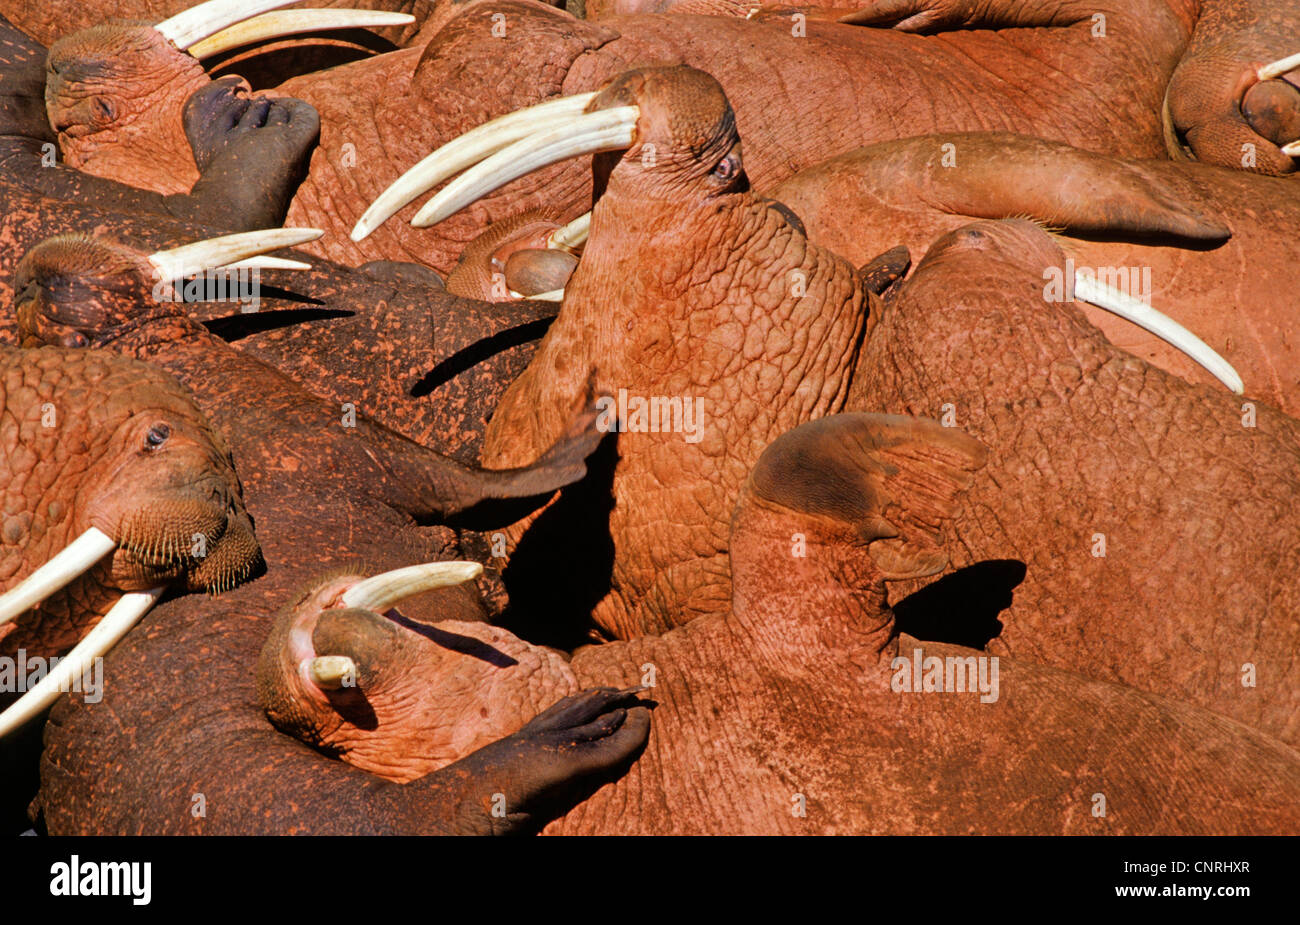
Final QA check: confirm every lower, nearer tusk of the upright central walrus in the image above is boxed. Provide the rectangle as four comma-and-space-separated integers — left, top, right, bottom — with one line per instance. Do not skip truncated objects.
411, 107, 641, 227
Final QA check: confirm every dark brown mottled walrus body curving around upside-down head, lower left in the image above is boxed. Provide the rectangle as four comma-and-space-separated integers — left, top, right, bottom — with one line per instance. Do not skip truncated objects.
36, 433, 649, 835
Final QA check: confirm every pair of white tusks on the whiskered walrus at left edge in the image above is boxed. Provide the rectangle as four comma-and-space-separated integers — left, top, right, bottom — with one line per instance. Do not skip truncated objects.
0, 526, 164, 739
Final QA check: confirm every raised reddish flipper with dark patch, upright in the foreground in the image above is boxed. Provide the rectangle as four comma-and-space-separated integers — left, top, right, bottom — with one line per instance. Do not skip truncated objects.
731, 413, 987, 646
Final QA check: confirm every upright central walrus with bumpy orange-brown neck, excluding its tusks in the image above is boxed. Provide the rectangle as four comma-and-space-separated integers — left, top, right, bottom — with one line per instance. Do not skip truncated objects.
484, 68, 875, 638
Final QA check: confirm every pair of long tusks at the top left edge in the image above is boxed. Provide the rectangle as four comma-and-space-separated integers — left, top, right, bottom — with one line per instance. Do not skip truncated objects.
155, 0, 415, 60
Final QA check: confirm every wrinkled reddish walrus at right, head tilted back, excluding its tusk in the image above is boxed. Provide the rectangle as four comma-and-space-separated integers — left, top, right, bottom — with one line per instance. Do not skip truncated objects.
849, 221, 1300, 746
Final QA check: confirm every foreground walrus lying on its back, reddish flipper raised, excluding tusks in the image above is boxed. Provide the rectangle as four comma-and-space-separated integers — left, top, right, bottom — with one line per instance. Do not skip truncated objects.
260, 414, 1300, 834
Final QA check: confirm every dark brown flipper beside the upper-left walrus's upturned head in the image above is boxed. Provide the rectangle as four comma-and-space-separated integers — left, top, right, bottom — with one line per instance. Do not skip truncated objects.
185, 78, 320, 230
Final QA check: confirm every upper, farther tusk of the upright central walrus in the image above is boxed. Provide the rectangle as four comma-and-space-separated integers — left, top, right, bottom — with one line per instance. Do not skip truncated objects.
351, 91, 595, 240
